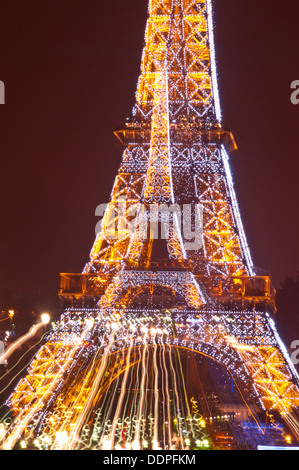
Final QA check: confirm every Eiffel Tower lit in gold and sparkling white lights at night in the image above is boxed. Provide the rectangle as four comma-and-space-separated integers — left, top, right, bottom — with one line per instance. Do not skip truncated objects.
1, 0, 299, 449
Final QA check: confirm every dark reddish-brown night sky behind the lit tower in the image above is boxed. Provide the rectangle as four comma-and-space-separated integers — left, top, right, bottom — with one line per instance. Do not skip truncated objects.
0, 0, 299, 301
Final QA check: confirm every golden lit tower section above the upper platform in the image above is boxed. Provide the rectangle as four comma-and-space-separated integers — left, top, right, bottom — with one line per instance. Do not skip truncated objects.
133, 0, 221, 126
